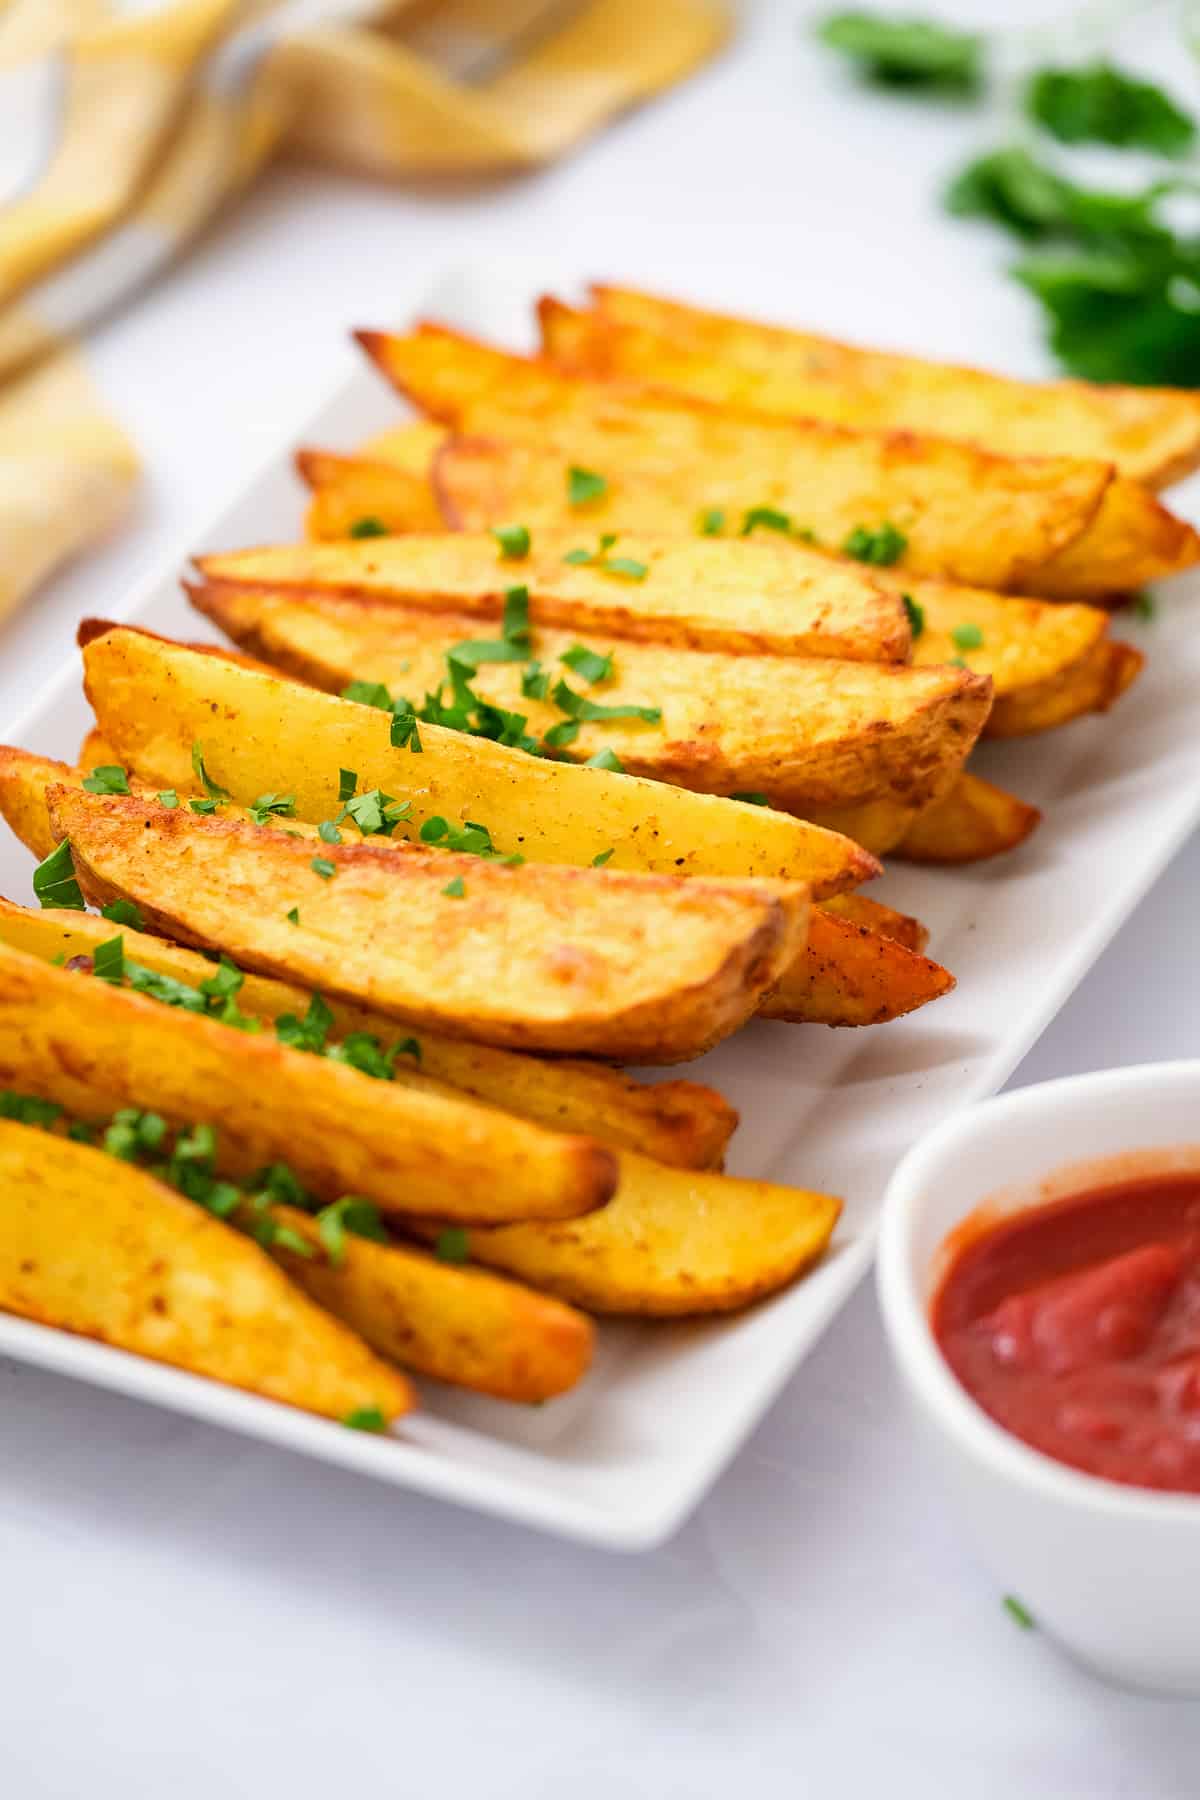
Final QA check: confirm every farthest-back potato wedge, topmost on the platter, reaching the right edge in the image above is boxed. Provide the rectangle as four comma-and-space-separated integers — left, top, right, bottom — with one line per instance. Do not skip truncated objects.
557, 295, 1200, 488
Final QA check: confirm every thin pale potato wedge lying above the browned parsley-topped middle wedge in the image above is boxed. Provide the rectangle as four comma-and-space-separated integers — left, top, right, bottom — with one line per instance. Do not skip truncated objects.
196, 536, 910, 662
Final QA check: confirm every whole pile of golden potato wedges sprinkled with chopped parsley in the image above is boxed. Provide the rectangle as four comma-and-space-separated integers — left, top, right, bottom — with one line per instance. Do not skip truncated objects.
0, 286, 1200, 1429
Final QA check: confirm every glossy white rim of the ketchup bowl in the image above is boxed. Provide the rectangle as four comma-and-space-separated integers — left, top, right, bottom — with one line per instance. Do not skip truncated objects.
876, 1058, 1200, 1530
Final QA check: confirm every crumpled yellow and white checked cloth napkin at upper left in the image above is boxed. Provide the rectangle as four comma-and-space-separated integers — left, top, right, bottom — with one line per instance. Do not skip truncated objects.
0, 0, 729, 616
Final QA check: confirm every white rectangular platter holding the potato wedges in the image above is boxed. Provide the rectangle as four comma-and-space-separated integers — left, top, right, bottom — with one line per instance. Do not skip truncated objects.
0, 265, 1200, 1550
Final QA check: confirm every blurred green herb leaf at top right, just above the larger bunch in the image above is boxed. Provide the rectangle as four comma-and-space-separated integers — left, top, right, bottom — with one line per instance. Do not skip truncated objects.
1025, 61, 1196, 157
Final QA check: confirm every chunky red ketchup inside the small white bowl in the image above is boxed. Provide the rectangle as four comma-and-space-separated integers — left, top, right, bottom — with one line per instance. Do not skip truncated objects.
930, 1174, 1200, 1494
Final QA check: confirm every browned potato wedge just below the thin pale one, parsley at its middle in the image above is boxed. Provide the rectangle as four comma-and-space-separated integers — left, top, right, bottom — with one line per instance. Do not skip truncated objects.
191, 583, 991, 815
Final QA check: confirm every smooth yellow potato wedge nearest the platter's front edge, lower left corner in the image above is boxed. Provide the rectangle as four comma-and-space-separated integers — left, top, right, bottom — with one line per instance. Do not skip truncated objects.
0, 1116, 414, 1422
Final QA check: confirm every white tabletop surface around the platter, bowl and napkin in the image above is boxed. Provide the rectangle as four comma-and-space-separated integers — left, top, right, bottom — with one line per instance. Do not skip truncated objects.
0, 0, 1200, 1800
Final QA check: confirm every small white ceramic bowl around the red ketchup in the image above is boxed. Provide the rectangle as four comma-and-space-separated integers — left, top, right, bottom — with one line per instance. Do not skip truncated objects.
878, 1062, 1200, 1696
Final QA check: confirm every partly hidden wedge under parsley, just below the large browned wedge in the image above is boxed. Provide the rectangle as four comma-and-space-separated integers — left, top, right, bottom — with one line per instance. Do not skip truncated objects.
0, 892, 737, 1168
